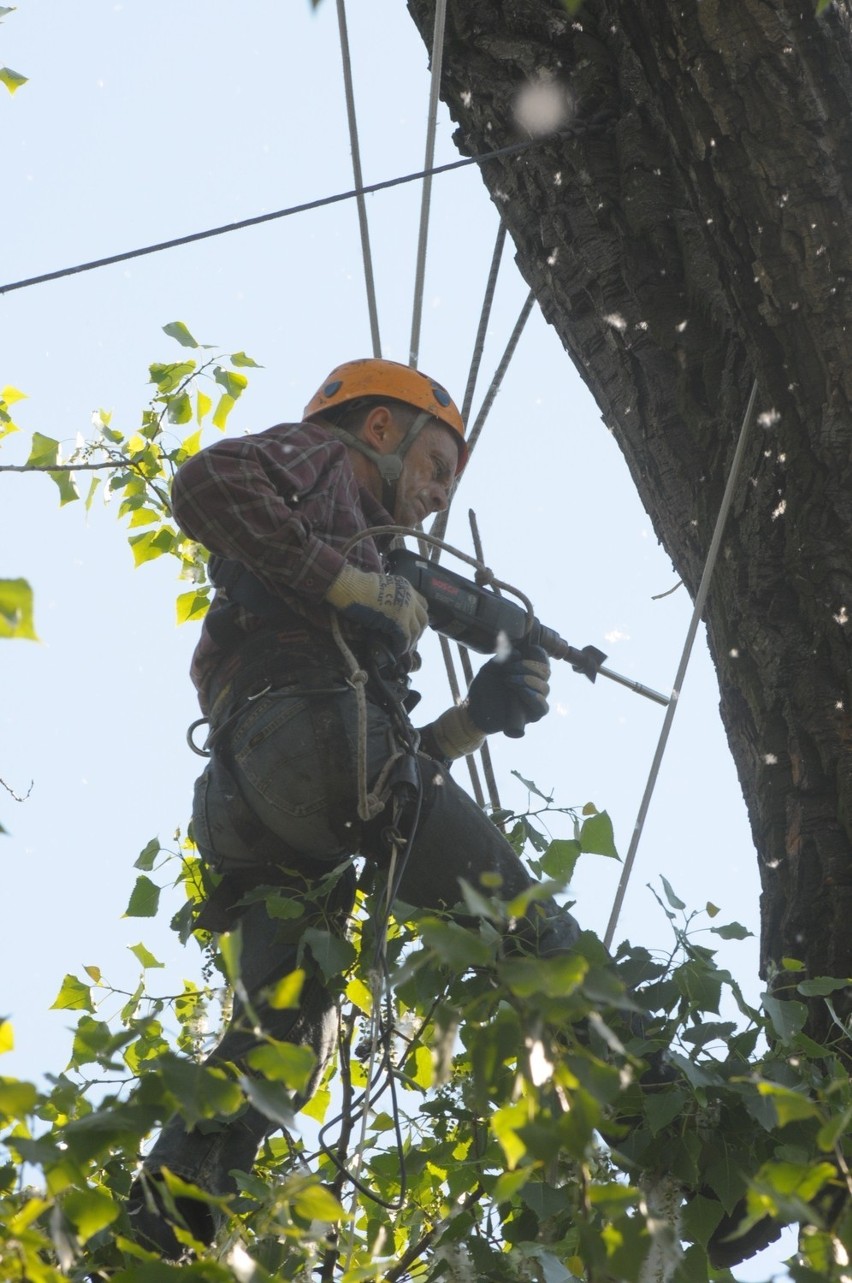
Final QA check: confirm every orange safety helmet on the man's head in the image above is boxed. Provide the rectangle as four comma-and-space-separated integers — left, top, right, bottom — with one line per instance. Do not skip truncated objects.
304, 357, 467, 476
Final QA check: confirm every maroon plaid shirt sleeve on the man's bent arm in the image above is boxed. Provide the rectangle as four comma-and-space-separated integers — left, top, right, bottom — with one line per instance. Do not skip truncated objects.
172, 430, 344, 602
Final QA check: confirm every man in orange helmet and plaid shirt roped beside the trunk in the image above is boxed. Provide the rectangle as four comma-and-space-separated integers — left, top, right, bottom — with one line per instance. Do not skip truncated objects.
130, 359, 579, 1257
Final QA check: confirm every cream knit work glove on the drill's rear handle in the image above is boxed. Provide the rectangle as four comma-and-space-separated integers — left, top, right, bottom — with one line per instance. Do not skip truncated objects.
326, 566, 429, 654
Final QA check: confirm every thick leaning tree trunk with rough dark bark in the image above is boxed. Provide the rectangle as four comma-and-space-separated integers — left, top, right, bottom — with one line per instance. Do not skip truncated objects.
408, 0, 852, 1016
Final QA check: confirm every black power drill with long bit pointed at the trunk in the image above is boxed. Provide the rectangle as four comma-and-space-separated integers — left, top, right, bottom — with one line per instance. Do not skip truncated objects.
388, 548, 670, 723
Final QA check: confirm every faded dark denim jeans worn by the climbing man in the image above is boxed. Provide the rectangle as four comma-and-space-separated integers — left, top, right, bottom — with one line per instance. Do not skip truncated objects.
145, 675, 580, 1193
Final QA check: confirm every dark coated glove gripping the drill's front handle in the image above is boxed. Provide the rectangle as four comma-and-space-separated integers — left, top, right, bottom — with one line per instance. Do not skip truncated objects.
467, 645, 550, 739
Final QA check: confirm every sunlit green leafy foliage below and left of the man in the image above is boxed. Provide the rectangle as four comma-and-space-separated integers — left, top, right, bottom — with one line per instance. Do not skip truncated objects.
0, 336, 852, 1283
